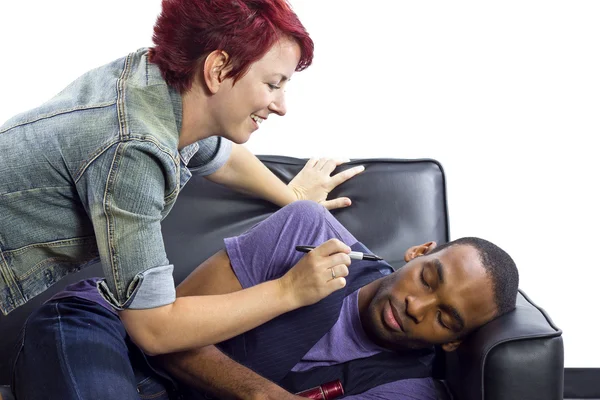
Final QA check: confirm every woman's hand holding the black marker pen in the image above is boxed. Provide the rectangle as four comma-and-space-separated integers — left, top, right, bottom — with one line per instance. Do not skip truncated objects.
279, 239, 350, 307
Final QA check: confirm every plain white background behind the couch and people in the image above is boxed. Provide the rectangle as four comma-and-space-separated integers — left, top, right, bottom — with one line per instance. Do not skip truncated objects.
0, 0, 600, 367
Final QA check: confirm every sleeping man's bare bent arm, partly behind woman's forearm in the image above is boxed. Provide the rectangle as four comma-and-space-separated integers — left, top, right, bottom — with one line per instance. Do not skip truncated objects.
158, 250, 301, 400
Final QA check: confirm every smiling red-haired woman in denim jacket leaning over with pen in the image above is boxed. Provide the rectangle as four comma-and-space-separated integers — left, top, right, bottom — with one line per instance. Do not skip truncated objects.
0, 0, 360, 399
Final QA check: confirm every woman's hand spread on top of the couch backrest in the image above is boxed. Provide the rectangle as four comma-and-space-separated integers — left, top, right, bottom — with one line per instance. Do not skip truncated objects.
288, 158, 365, 210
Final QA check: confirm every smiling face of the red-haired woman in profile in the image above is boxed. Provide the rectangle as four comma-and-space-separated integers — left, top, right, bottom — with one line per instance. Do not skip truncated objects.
211, 38, 300, 144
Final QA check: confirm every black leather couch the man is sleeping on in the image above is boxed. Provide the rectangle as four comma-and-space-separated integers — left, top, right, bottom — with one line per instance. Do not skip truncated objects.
0, 156, 563, 400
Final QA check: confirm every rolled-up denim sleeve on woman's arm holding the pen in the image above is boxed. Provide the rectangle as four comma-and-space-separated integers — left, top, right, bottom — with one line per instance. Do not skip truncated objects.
77, 140, 179, 310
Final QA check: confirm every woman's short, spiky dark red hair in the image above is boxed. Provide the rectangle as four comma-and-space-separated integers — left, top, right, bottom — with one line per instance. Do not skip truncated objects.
150, 0, 314, 93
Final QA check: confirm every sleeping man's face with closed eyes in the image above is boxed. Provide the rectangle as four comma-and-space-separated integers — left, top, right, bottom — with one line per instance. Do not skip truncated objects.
361, 245, 496, 351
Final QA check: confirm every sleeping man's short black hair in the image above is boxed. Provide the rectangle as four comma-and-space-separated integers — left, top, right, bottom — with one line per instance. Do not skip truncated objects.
429, 237, 519, 317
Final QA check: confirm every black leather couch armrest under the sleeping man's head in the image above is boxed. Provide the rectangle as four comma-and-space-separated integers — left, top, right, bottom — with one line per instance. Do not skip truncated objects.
446, 290, 564, 400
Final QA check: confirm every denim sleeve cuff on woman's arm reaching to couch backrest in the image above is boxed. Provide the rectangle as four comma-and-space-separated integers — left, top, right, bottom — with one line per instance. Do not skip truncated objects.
187, 136, 232, 176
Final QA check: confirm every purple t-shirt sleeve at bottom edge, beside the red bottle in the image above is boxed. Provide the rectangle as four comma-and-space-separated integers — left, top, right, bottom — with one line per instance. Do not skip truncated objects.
344, 378, 437, 400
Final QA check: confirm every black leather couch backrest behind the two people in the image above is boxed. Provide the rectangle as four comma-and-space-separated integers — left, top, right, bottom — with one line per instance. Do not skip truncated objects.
163, 156, 448, 282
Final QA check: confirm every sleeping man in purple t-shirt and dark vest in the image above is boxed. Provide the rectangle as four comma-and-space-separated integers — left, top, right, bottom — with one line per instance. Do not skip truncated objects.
154, 201, 519, 400
